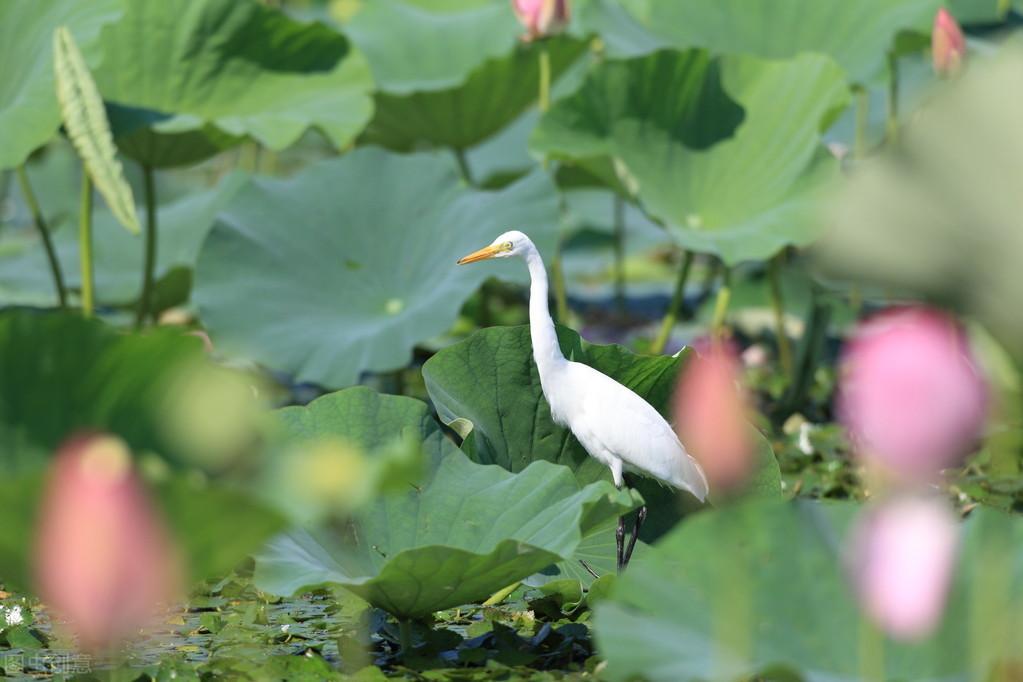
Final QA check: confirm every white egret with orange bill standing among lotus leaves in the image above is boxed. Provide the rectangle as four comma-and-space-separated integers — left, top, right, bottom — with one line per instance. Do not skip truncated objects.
458, 230, 707, 571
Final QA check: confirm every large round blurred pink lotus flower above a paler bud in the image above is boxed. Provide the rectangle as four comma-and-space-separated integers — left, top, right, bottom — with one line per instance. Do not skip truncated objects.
838, 308, 987, 480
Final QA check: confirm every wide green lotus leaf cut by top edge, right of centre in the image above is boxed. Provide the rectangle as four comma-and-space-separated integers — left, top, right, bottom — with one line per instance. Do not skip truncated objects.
609, 0, 940, 83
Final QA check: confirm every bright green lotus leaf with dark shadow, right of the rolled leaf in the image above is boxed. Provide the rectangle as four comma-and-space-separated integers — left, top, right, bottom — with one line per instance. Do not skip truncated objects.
96, 0, 372, 165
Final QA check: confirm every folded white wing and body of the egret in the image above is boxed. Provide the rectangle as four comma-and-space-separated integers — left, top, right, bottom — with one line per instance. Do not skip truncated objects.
568, 363, 707, 500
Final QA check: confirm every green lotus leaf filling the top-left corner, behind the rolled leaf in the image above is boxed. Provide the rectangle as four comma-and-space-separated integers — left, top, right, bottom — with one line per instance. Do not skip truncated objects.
0, 0, 123, 169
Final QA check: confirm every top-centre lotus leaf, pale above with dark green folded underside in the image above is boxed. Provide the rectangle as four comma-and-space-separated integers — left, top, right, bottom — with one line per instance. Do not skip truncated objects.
347, 0, 584, 150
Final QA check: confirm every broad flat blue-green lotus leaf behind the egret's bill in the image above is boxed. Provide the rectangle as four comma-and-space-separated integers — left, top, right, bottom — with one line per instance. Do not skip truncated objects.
195, 147, 558, 387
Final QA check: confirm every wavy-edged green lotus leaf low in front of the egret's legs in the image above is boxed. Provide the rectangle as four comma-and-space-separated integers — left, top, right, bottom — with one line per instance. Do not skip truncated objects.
255, 388, 640, 619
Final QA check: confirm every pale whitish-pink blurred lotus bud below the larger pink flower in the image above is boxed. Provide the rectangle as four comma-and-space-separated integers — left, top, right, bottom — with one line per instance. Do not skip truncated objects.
848, 497, 959, 640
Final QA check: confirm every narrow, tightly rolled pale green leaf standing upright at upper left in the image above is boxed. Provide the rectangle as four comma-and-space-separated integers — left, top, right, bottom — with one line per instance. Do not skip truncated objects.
53, 27, 139, 234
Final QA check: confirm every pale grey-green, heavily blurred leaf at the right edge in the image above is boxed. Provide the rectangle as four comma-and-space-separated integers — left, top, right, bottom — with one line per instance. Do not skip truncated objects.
818, 46, 1023, 361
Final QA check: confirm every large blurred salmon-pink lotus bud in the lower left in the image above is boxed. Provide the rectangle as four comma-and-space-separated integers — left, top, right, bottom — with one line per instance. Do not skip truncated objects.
34, 435, 180, 651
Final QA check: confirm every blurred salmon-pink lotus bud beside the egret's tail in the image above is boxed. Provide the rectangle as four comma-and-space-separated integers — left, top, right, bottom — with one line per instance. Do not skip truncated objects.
675, 342, 753, 491
